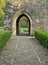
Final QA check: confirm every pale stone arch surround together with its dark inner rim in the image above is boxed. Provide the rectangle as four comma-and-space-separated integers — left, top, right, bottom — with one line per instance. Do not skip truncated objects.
12, 10, 33, 35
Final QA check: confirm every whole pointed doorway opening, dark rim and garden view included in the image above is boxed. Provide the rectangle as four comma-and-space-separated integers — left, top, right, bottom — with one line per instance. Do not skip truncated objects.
16, 14, 30, 35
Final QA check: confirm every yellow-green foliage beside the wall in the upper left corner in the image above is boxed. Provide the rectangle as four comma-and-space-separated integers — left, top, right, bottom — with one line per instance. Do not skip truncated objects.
0, 0, 9, 26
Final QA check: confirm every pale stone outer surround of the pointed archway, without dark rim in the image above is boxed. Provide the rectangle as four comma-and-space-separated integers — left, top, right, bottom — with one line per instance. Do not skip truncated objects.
12, 10, 33, 35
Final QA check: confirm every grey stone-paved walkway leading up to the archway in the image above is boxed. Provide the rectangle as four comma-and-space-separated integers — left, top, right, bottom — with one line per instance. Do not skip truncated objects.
0, 36, 48, 65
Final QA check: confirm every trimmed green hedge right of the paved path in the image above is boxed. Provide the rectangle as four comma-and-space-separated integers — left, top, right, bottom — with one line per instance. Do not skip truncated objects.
35, 30, 48, 48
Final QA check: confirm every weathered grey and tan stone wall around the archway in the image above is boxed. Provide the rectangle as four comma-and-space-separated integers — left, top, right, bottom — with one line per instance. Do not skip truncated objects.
4, 0, 48, 35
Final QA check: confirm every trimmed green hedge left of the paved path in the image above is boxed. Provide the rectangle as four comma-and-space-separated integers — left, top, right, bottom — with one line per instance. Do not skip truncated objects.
0, 30, 11, 48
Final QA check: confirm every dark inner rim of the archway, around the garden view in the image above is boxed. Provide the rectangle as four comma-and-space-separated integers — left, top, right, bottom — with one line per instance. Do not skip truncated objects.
16, 14, 30, 35
